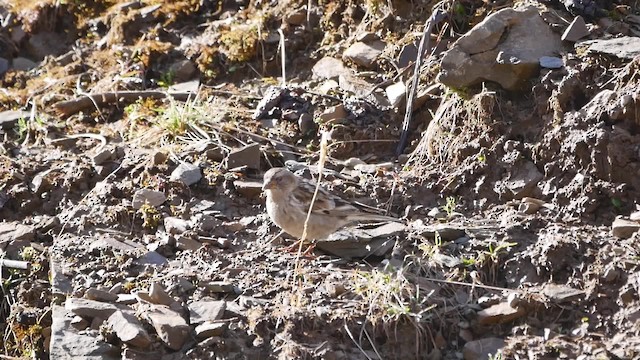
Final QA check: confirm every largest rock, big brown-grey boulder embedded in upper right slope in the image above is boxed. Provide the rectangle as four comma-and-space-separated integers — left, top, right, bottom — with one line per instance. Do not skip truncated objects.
438, 7, 562, 90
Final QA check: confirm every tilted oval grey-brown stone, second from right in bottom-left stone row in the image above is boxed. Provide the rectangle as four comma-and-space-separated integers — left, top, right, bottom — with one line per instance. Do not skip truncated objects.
145, 306, 190, 350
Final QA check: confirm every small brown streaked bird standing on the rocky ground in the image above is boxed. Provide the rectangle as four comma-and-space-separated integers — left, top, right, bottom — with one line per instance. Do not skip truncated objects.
262, 167, 400, 246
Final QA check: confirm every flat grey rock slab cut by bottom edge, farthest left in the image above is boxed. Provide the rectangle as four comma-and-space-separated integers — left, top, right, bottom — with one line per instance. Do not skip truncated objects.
49, 305, 120, 360
